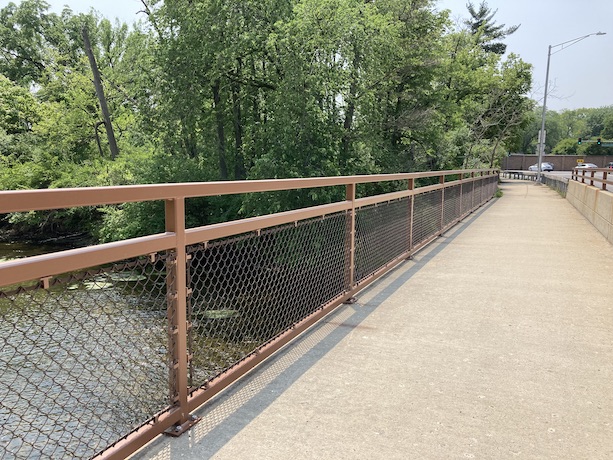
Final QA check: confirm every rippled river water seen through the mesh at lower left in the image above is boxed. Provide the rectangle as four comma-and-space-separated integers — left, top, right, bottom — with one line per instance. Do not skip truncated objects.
0, 241, 280, 460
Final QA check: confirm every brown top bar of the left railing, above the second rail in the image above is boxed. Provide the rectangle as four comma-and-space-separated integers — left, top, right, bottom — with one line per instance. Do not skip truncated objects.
0, 168, 498, 213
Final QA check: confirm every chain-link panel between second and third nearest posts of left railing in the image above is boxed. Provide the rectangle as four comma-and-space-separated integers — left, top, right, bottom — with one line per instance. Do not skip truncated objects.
355, 198, 411, 281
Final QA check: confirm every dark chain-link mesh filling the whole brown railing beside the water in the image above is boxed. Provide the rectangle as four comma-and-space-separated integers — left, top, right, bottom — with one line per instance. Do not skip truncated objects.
0, 171, 497, 459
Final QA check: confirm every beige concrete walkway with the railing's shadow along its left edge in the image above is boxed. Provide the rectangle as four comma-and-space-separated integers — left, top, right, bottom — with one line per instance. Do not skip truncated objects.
136, 181, 613, 460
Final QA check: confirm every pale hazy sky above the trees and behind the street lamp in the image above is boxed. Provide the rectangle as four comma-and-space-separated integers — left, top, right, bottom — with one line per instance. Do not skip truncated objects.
0, 0, 613, 111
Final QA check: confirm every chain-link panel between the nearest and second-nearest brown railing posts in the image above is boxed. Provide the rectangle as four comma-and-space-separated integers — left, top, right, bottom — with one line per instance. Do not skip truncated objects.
188, 213, 349, 387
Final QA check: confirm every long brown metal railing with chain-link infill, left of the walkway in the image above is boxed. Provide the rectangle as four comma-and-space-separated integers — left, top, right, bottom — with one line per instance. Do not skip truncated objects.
0, 170, 498, 459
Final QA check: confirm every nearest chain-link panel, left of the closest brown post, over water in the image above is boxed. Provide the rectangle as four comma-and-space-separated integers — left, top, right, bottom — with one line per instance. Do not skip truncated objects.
0, 256, 168, 459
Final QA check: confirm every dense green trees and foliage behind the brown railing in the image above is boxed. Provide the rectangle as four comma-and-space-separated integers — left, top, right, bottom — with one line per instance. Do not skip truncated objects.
0, 0, 533, 240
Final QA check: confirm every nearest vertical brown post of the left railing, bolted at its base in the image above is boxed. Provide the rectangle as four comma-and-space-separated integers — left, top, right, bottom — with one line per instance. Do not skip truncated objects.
165, 198, 195, 436
